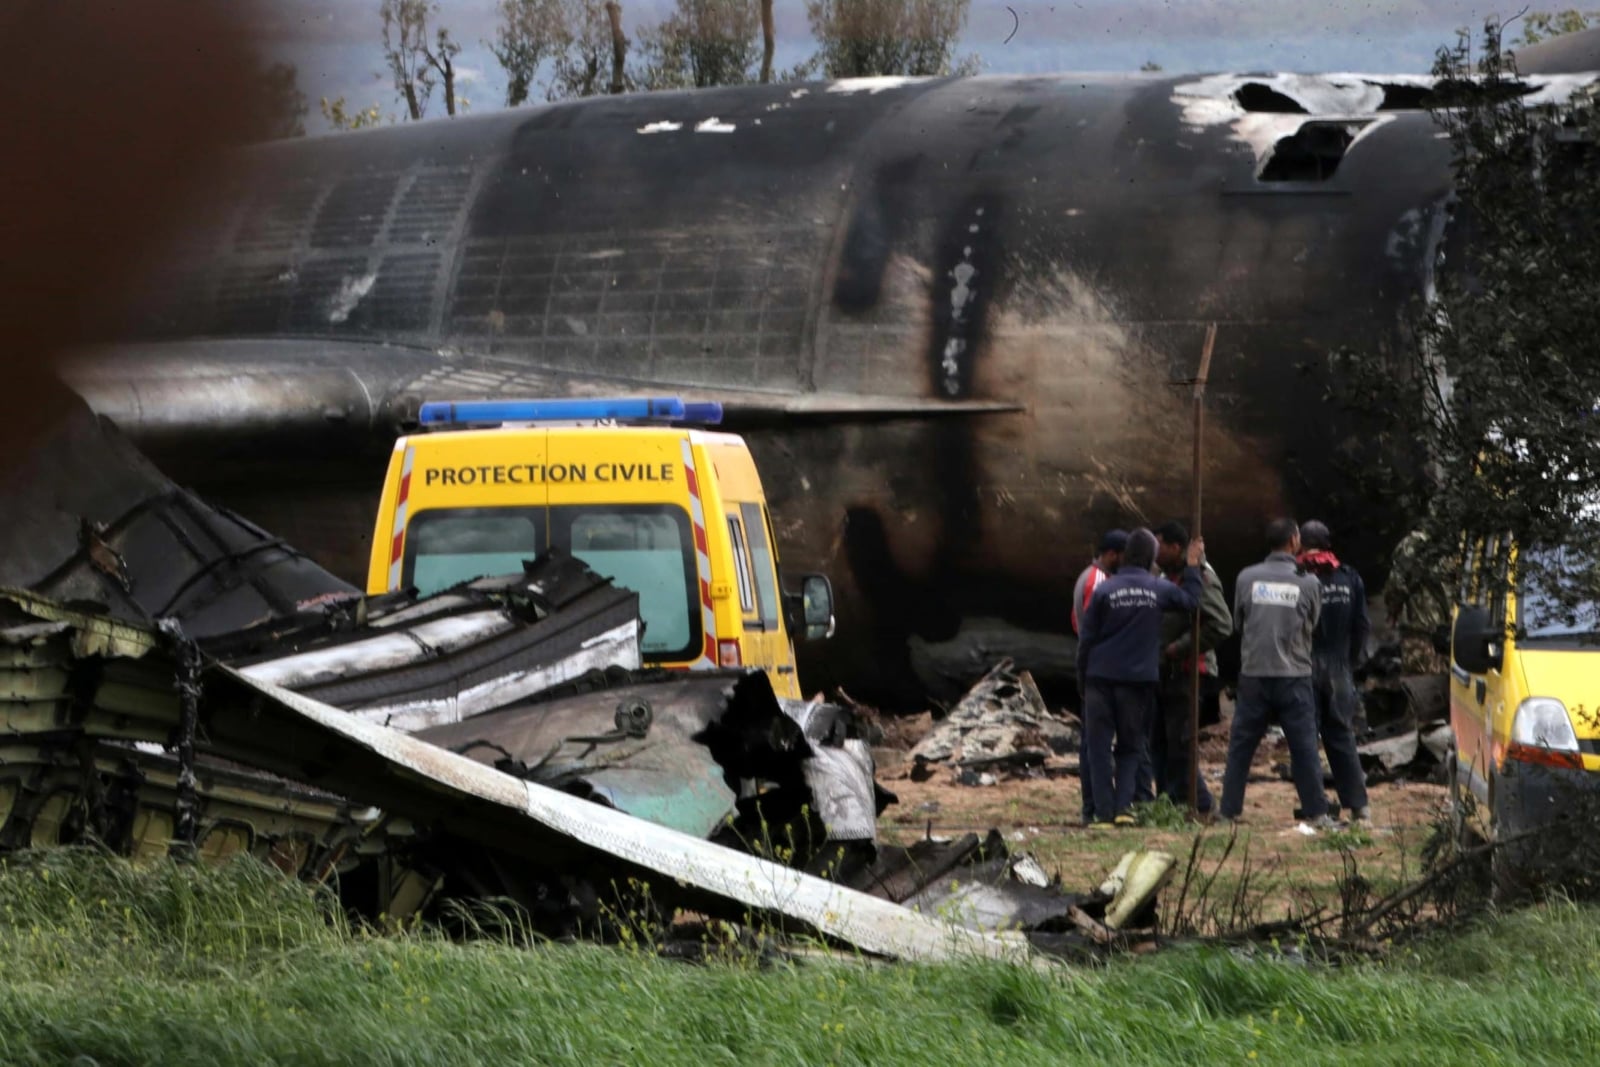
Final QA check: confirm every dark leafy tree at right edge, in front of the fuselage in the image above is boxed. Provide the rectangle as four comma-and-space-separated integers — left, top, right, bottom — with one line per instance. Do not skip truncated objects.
1349, 21, 1600, 630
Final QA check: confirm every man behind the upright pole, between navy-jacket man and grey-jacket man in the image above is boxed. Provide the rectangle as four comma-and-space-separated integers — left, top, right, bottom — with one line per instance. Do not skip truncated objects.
1150, 522, 1234, 814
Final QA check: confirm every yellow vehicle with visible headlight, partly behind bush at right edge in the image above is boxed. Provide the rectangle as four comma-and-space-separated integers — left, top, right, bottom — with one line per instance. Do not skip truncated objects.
1448, 539, 1600, 857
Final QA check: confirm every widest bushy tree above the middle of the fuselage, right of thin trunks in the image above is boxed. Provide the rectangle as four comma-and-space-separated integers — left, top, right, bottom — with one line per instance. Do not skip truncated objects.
805, 0, 979, 78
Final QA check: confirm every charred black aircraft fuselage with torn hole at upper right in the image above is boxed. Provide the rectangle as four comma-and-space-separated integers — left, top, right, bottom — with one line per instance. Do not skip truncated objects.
59, 75, 1579, 702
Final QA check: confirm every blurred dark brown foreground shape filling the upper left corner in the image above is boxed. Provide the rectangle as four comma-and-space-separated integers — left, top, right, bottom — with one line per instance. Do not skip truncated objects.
0, 0, 254, 470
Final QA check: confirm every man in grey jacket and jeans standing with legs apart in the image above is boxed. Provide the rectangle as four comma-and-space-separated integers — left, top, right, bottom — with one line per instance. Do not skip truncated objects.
1221, 518, 1333, 829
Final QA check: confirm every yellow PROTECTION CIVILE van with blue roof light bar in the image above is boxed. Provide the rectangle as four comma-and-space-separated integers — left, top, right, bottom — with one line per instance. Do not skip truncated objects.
366, 397, 834, 697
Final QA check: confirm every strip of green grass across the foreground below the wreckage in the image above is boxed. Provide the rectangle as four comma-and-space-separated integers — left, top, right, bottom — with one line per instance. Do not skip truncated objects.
0, 851, 1600, 1067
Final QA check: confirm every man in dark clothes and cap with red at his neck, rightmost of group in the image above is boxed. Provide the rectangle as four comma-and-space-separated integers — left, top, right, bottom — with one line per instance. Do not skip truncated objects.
1299, 522, 1371, 822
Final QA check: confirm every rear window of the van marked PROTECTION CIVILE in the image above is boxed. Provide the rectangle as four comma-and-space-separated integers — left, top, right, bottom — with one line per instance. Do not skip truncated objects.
403, 504, 701, 661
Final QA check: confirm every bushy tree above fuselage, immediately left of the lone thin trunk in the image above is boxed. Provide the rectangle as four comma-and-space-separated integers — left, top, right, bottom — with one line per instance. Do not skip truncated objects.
635, 0, 771, 90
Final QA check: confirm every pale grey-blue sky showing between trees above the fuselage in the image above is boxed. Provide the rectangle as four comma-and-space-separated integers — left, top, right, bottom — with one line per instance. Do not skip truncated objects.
258, 0, 1536, 131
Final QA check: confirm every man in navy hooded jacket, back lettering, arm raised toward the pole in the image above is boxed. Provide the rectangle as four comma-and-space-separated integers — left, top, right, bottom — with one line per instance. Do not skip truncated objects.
1078, 530, 1205, 825
